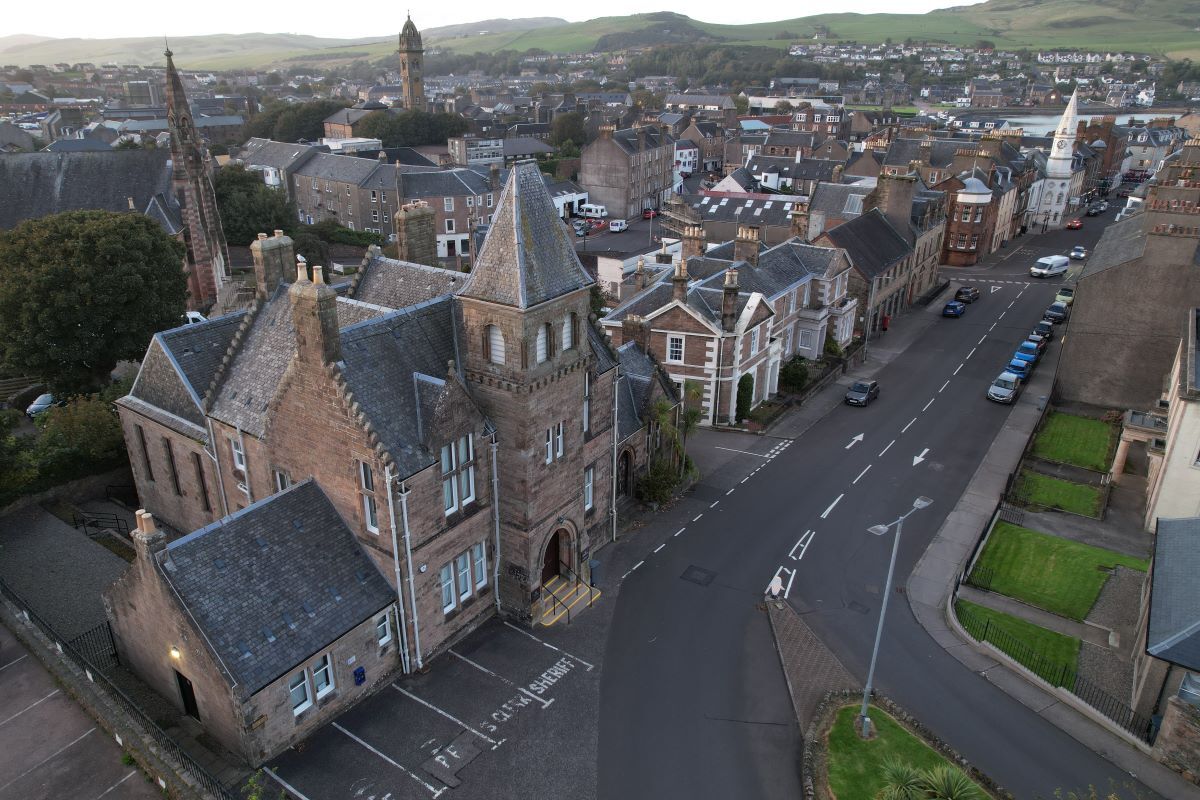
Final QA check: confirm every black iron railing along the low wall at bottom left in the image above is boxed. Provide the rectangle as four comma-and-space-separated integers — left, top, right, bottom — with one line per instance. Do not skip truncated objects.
0, 581, 239, 800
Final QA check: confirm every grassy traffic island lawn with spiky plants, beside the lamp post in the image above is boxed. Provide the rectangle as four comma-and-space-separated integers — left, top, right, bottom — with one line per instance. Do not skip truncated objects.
829, 705, 984, 800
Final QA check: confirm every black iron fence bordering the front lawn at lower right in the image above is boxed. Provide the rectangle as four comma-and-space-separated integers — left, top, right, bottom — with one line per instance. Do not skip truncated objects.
955, 606, 1153, 744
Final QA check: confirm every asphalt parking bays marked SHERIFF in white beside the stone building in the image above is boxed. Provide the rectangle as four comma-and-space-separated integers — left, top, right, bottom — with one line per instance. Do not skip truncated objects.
268, 620, 599, 800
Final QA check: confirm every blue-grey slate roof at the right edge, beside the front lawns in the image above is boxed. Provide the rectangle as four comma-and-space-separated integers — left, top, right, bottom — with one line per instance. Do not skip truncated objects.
1146, 517, 1200, 670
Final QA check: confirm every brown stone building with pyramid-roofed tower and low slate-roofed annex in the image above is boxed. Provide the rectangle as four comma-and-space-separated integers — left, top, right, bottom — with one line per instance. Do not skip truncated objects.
106, 162, 678, 763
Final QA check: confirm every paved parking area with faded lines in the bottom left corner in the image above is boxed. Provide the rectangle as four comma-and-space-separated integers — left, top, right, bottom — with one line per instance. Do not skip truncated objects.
0, 626, 162, 800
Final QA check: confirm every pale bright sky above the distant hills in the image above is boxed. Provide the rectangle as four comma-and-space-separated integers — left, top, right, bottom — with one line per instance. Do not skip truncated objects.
7, 0, 979, 38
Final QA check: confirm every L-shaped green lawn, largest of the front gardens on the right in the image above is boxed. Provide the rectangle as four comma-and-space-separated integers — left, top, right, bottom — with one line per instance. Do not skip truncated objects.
972, 522, 1147, 620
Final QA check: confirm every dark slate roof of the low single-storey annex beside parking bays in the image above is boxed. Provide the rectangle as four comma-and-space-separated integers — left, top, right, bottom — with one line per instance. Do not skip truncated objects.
155, 479, 395, 694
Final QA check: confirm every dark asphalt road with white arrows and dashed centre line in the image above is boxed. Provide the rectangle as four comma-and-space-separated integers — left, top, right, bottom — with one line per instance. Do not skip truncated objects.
599, 212, 1148, 799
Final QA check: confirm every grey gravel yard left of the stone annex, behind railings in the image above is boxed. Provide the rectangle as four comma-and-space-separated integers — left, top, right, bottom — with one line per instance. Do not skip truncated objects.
0, 506, 128, 639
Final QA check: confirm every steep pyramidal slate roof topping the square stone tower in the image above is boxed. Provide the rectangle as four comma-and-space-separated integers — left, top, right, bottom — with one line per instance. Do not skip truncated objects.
461, 161, 594, 308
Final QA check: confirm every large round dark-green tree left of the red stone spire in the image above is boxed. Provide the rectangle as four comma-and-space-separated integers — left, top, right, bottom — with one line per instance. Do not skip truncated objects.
0, 211, 187, 395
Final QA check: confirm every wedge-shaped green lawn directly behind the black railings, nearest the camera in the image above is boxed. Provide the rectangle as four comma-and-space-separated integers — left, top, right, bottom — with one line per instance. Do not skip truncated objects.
954, 600, 1079, 687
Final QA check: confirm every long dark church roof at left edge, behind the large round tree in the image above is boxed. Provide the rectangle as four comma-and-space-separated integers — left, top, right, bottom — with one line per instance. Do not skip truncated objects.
0, 148, 174, 230
